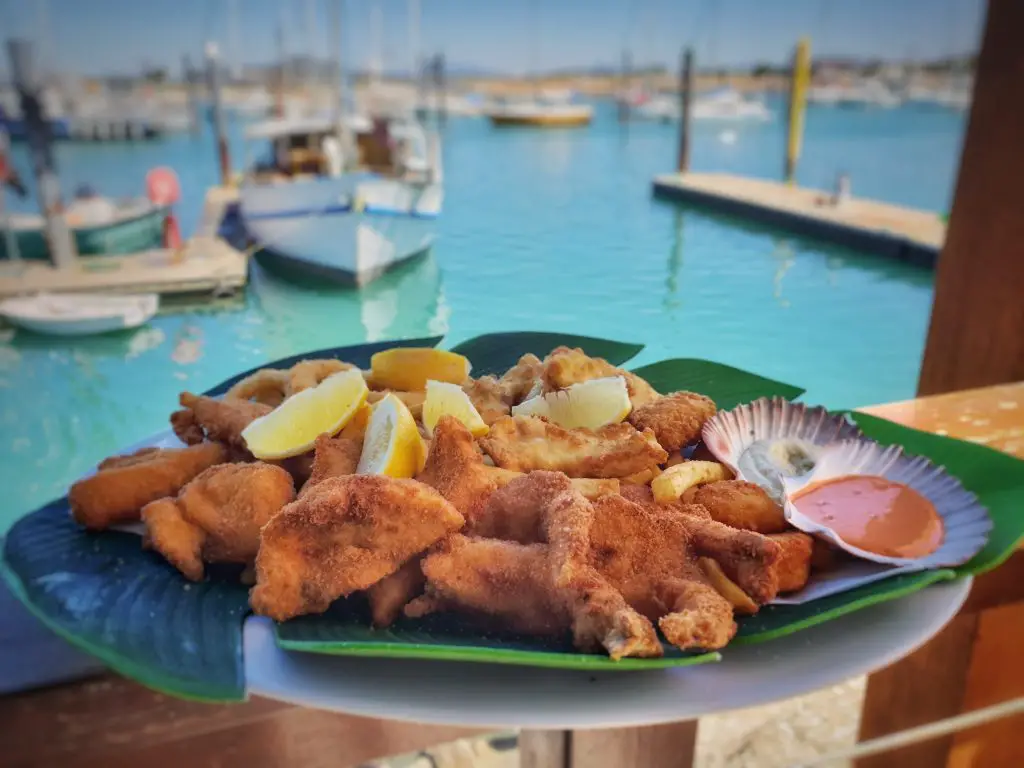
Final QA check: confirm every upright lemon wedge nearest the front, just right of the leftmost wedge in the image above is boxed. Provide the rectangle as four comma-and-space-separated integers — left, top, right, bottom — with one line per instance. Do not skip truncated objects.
355, 394, 424, 477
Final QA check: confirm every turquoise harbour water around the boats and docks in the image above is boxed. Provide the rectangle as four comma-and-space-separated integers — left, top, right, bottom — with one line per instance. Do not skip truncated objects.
0, 103, 964, 531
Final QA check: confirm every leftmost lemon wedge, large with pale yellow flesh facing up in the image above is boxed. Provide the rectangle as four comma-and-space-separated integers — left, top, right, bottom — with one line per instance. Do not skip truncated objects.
242, 370, 370, 459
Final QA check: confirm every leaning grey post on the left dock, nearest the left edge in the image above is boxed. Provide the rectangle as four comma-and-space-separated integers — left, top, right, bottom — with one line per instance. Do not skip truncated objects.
7, 39, 78, 268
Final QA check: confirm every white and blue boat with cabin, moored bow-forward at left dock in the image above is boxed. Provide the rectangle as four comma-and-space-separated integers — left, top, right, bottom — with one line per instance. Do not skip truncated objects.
239, 118, 443, 286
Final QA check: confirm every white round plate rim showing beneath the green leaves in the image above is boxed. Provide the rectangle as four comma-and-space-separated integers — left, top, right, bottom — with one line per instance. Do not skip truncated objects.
245, 578, 972, 729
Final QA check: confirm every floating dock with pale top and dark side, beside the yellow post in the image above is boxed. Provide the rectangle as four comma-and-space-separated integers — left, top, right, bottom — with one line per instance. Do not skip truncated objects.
654, 172, 946, 266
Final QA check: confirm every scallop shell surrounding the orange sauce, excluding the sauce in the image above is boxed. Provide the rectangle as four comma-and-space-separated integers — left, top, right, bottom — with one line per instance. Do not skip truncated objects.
783, 439, 992, 569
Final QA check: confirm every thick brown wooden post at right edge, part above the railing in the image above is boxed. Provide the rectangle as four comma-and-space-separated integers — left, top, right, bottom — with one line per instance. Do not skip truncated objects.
918, 0, 1024, 394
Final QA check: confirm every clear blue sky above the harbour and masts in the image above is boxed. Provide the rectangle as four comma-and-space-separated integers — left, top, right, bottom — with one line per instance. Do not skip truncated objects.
0, 0, 984, 75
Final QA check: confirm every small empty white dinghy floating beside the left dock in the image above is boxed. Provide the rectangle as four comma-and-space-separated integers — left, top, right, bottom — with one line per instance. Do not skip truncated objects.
0, 293, 160, 336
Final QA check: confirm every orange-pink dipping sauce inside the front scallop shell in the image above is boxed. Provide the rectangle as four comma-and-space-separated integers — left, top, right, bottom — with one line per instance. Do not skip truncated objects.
792, 475, 945, 558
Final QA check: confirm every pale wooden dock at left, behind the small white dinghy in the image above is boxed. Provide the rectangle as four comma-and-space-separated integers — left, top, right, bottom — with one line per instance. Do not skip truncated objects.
0, 187, 249, 298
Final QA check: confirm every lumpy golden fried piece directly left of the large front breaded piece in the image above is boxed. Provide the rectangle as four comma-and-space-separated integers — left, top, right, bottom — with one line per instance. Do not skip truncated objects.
142, 464, 295, 582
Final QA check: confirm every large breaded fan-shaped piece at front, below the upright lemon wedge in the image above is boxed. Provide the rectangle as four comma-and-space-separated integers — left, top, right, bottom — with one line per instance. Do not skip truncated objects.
249, 475, 465, 622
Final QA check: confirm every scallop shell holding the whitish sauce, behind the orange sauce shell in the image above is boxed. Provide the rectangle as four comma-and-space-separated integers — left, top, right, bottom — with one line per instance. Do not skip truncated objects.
701, 397, 862, 502
